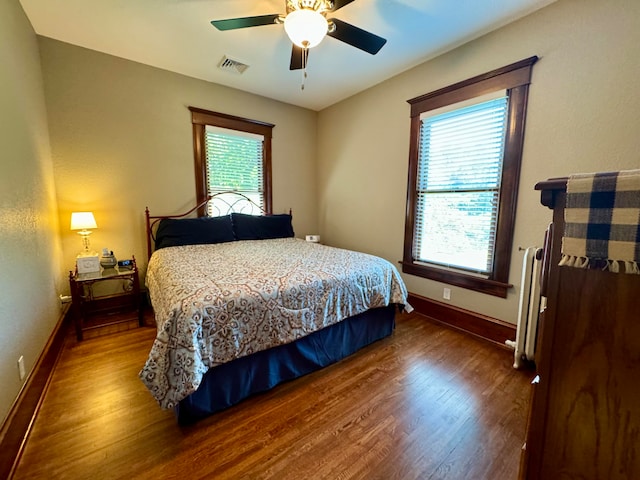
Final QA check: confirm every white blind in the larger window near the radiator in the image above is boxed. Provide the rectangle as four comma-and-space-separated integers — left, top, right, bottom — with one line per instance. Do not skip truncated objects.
413, 92, 508, 275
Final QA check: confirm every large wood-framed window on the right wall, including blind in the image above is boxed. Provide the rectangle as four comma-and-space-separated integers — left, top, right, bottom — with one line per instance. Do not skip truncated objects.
402, 57, 537, 297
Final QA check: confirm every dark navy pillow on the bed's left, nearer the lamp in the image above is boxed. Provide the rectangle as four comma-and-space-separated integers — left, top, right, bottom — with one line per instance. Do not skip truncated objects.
156, 215, 235, 250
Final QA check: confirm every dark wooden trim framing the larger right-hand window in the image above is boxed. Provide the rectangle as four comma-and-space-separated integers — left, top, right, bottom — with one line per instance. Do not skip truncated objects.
402, 56, 538, 298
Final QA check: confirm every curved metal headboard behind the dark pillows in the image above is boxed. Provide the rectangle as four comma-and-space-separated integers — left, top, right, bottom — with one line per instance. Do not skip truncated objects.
144, 190, 278, 260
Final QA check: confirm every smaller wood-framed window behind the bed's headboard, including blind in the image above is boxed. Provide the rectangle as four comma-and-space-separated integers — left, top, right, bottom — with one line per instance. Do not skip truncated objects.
189, 107, 273, 216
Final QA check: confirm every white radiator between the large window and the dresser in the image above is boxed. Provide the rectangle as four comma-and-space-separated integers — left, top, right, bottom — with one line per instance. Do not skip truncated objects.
505, 247, 542, 368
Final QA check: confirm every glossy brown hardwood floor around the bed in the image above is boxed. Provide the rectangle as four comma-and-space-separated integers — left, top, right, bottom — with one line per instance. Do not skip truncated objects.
13, 314, 531, 480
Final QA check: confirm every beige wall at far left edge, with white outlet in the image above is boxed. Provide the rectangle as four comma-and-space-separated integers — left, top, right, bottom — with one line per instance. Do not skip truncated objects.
0, 0, 64, 422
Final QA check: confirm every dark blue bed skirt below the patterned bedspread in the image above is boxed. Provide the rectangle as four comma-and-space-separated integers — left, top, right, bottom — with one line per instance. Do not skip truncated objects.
176, 305, 397, 424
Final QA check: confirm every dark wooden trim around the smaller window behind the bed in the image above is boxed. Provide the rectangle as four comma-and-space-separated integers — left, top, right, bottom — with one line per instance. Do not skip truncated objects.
189, 107, 275, 217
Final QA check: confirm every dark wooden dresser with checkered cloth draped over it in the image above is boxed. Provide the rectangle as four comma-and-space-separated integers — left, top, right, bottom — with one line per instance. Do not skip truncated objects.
520, 179, 640, 480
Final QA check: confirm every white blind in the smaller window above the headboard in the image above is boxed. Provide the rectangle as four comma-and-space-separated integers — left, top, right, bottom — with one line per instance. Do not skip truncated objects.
205, 125, 264, 214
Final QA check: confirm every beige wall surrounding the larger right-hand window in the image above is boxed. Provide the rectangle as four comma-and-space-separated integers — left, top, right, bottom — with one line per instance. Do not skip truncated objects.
318, 0, 640, 322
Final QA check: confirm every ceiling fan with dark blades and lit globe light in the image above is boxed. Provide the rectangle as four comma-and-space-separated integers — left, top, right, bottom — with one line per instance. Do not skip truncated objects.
211, 0, 387, 70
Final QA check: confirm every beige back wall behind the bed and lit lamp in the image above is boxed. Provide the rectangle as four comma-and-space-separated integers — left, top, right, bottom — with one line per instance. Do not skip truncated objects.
40, 38, 317, 280
